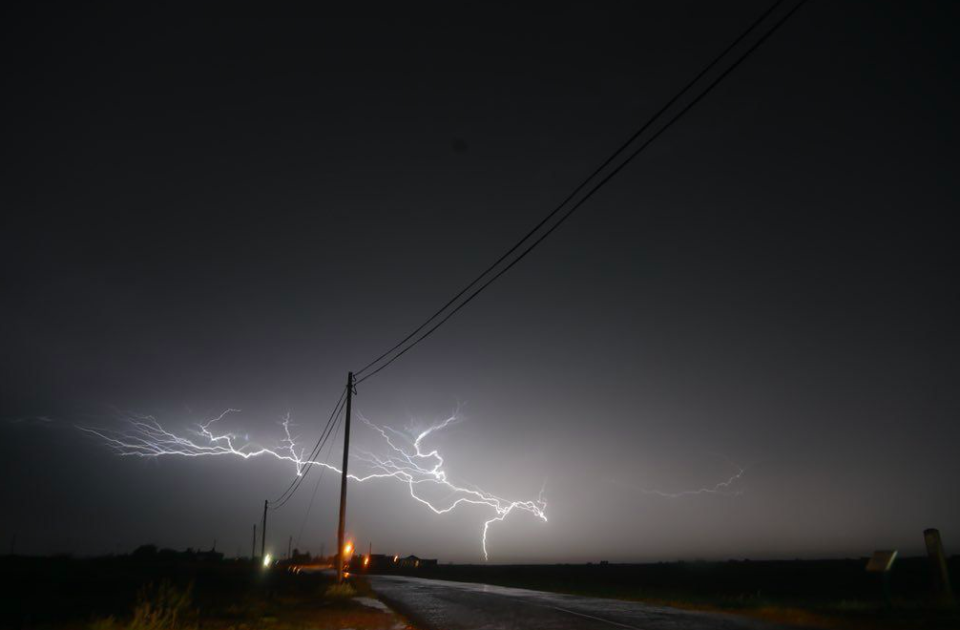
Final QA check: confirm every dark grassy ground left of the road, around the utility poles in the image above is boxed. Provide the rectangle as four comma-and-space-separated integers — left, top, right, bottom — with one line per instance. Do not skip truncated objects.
0, 554, 396, 630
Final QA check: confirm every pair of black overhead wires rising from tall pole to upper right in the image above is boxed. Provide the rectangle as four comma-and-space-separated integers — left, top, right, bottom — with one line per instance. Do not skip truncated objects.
357, 0, 806, 385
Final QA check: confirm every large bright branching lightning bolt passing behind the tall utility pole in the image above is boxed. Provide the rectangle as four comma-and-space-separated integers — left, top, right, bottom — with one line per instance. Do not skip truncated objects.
77, 409, 547, 560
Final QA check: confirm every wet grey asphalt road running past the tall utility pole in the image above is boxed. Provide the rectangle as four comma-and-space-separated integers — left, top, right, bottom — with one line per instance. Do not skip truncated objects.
368, 575, 784, 630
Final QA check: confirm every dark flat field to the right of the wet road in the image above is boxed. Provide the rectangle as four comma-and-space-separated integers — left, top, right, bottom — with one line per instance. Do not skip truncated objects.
372, 556, 960, 628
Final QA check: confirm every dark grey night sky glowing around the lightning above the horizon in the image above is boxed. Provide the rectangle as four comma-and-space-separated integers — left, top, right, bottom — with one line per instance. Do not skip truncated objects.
0, 1, 960, 562
